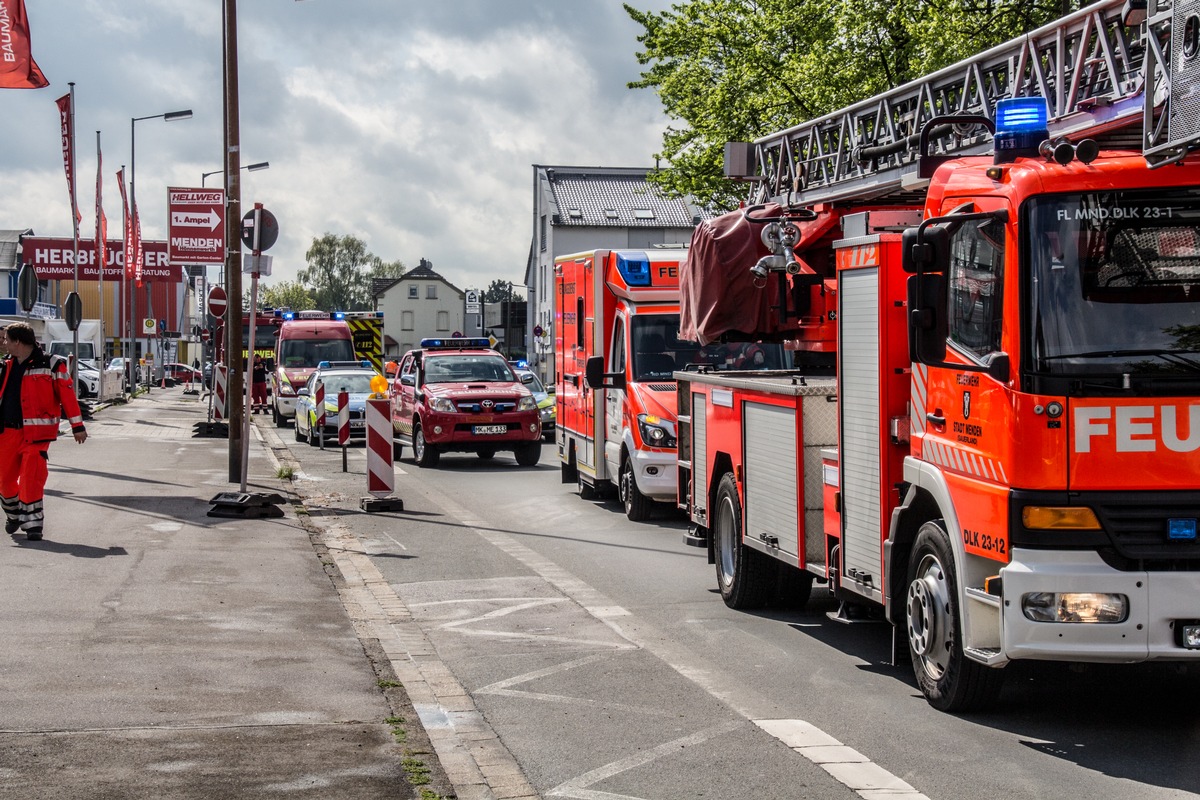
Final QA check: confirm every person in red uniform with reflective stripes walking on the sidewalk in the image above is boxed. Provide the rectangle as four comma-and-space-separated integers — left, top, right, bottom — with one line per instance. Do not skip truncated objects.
0, 323, 88, 541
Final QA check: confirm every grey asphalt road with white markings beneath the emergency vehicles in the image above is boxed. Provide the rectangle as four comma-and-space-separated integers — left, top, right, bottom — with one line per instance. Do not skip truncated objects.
276, 420, 1200, 800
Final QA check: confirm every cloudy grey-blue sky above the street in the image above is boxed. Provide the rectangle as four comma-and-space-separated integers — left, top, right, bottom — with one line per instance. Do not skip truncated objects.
0, 0, 671, 289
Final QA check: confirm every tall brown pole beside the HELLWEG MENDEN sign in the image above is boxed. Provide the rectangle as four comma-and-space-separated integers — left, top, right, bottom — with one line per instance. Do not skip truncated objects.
223, 0, 246, 483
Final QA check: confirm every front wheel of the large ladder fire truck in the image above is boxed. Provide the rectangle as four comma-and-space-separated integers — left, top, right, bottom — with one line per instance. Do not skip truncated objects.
905, 519, 1004, 711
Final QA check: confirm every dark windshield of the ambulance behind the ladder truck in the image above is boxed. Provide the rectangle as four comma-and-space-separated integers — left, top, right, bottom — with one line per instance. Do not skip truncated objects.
630, 314, 787, 380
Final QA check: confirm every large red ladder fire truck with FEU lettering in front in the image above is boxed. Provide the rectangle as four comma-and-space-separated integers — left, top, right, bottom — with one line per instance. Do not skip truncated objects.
676, 0, 1200, 711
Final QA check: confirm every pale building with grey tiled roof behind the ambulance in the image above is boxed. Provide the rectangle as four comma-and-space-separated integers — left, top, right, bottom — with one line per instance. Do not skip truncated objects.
524, 164, 709, 381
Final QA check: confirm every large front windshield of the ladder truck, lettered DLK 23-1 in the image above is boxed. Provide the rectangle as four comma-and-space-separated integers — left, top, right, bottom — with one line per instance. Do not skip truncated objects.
1021, 190, 1200, 387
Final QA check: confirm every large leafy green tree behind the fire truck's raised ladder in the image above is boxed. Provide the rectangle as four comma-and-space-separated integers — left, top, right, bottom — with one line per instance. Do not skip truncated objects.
625, 0, 1084, 210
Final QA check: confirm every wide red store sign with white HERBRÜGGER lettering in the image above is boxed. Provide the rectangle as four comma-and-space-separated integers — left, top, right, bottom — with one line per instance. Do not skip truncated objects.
20, 236, 177, 283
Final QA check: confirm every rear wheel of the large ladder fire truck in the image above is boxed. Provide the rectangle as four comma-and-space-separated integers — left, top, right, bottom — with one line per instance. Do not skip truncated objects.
710, 473, 774, 608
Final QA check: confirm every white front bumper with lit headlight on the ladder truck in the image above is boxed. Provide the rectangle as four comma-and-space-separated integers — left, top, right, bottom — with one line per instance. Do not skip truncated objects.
1001, 548, 1200, 663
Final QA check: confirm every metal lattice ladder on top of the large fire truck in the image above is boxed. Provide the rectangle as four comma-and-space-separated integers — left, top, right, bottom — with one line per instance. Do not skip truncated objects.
726, 0, 1200, 206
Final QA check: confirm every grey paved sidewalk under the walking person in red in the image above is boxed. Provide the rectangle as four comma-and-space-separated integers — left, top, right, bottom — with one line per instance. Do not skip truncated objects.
0, 387, 452, 800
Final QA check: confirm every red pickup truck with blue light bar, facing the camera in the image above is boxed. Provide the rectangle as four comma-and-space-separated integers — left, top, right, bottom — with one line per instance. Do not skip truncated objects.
390, 338, 541, 467
